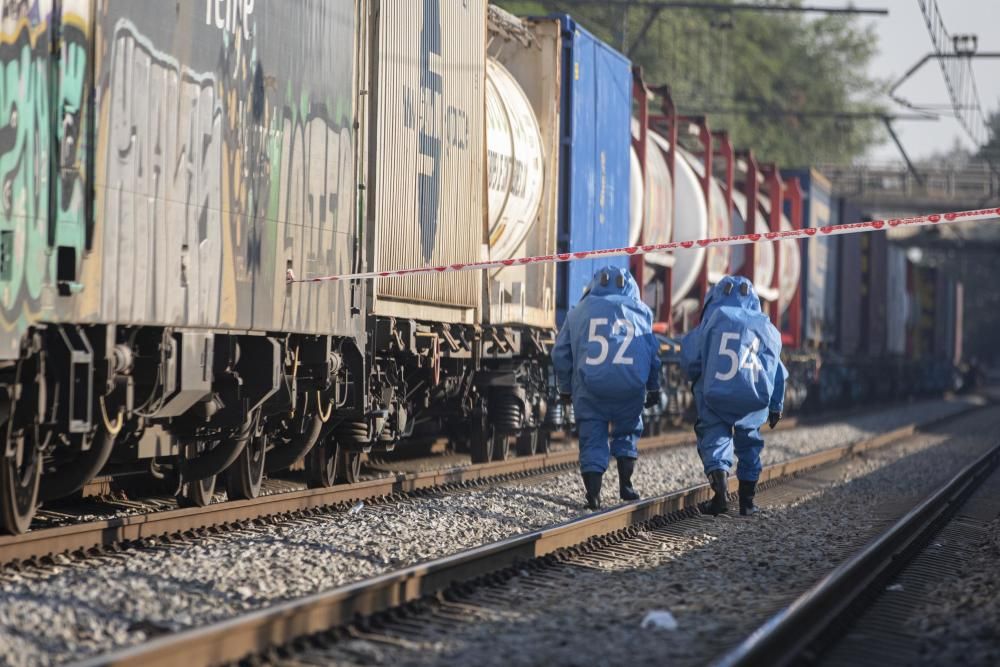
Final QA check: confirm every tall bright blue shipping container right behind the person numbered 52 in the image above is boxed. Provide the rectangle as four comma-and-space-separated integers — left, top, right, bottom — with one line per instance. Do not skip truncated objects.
556, 16, 632, 324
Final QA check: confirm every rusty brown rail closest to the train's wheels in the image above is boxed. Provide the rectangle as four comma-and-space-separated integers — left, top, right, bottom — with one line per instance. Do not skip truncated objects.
0, 433, 693, 564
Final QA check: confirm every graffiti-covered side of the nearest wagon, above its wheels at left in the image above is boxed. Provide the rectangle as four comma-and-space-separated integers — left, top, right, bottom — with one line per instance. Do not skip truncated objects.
0, 0, 360, 358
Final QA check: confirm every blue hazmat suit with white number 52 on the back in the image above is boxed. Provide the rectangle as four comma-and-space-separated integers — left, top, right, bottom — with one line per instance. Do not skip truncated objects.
552, 266, 660, 473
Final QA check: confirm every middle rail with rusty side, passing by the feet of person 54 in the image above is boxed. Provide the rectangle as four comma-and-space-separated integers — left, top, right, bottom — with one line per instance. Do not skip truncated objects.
70, 418, 952, 667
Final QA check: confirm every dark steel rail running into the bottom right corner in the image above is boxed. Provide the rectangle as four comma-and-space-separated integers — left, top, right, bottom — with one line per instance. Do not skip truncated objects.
713, 444, 1000, 667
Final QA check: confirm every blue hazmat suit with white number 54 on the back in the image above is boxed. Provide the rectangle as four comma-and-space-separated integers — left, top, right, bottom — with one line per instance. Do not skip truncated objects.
681, 276, 788, 482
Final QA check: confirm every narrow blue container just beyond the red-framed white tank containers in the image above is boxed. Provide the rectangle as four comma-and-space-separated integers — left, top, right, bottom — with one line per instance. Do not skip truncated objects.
782, 169, 840, 349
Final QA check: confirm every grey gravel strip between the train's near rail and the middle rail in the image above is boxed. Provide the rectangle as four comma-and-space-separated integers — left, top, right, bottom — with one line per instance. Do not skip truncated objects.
0, 398, 975, 665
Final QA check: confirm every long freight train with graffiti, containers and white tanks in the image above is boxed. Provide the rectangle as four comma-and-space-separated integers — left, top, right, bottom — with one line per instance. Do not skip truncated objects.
0, 0, 960, 533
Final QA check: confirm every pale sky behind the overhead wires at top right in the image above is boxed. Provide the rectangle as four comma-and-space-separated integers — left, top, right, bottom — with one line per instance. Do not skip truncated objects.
828, 0, 1000, 162
